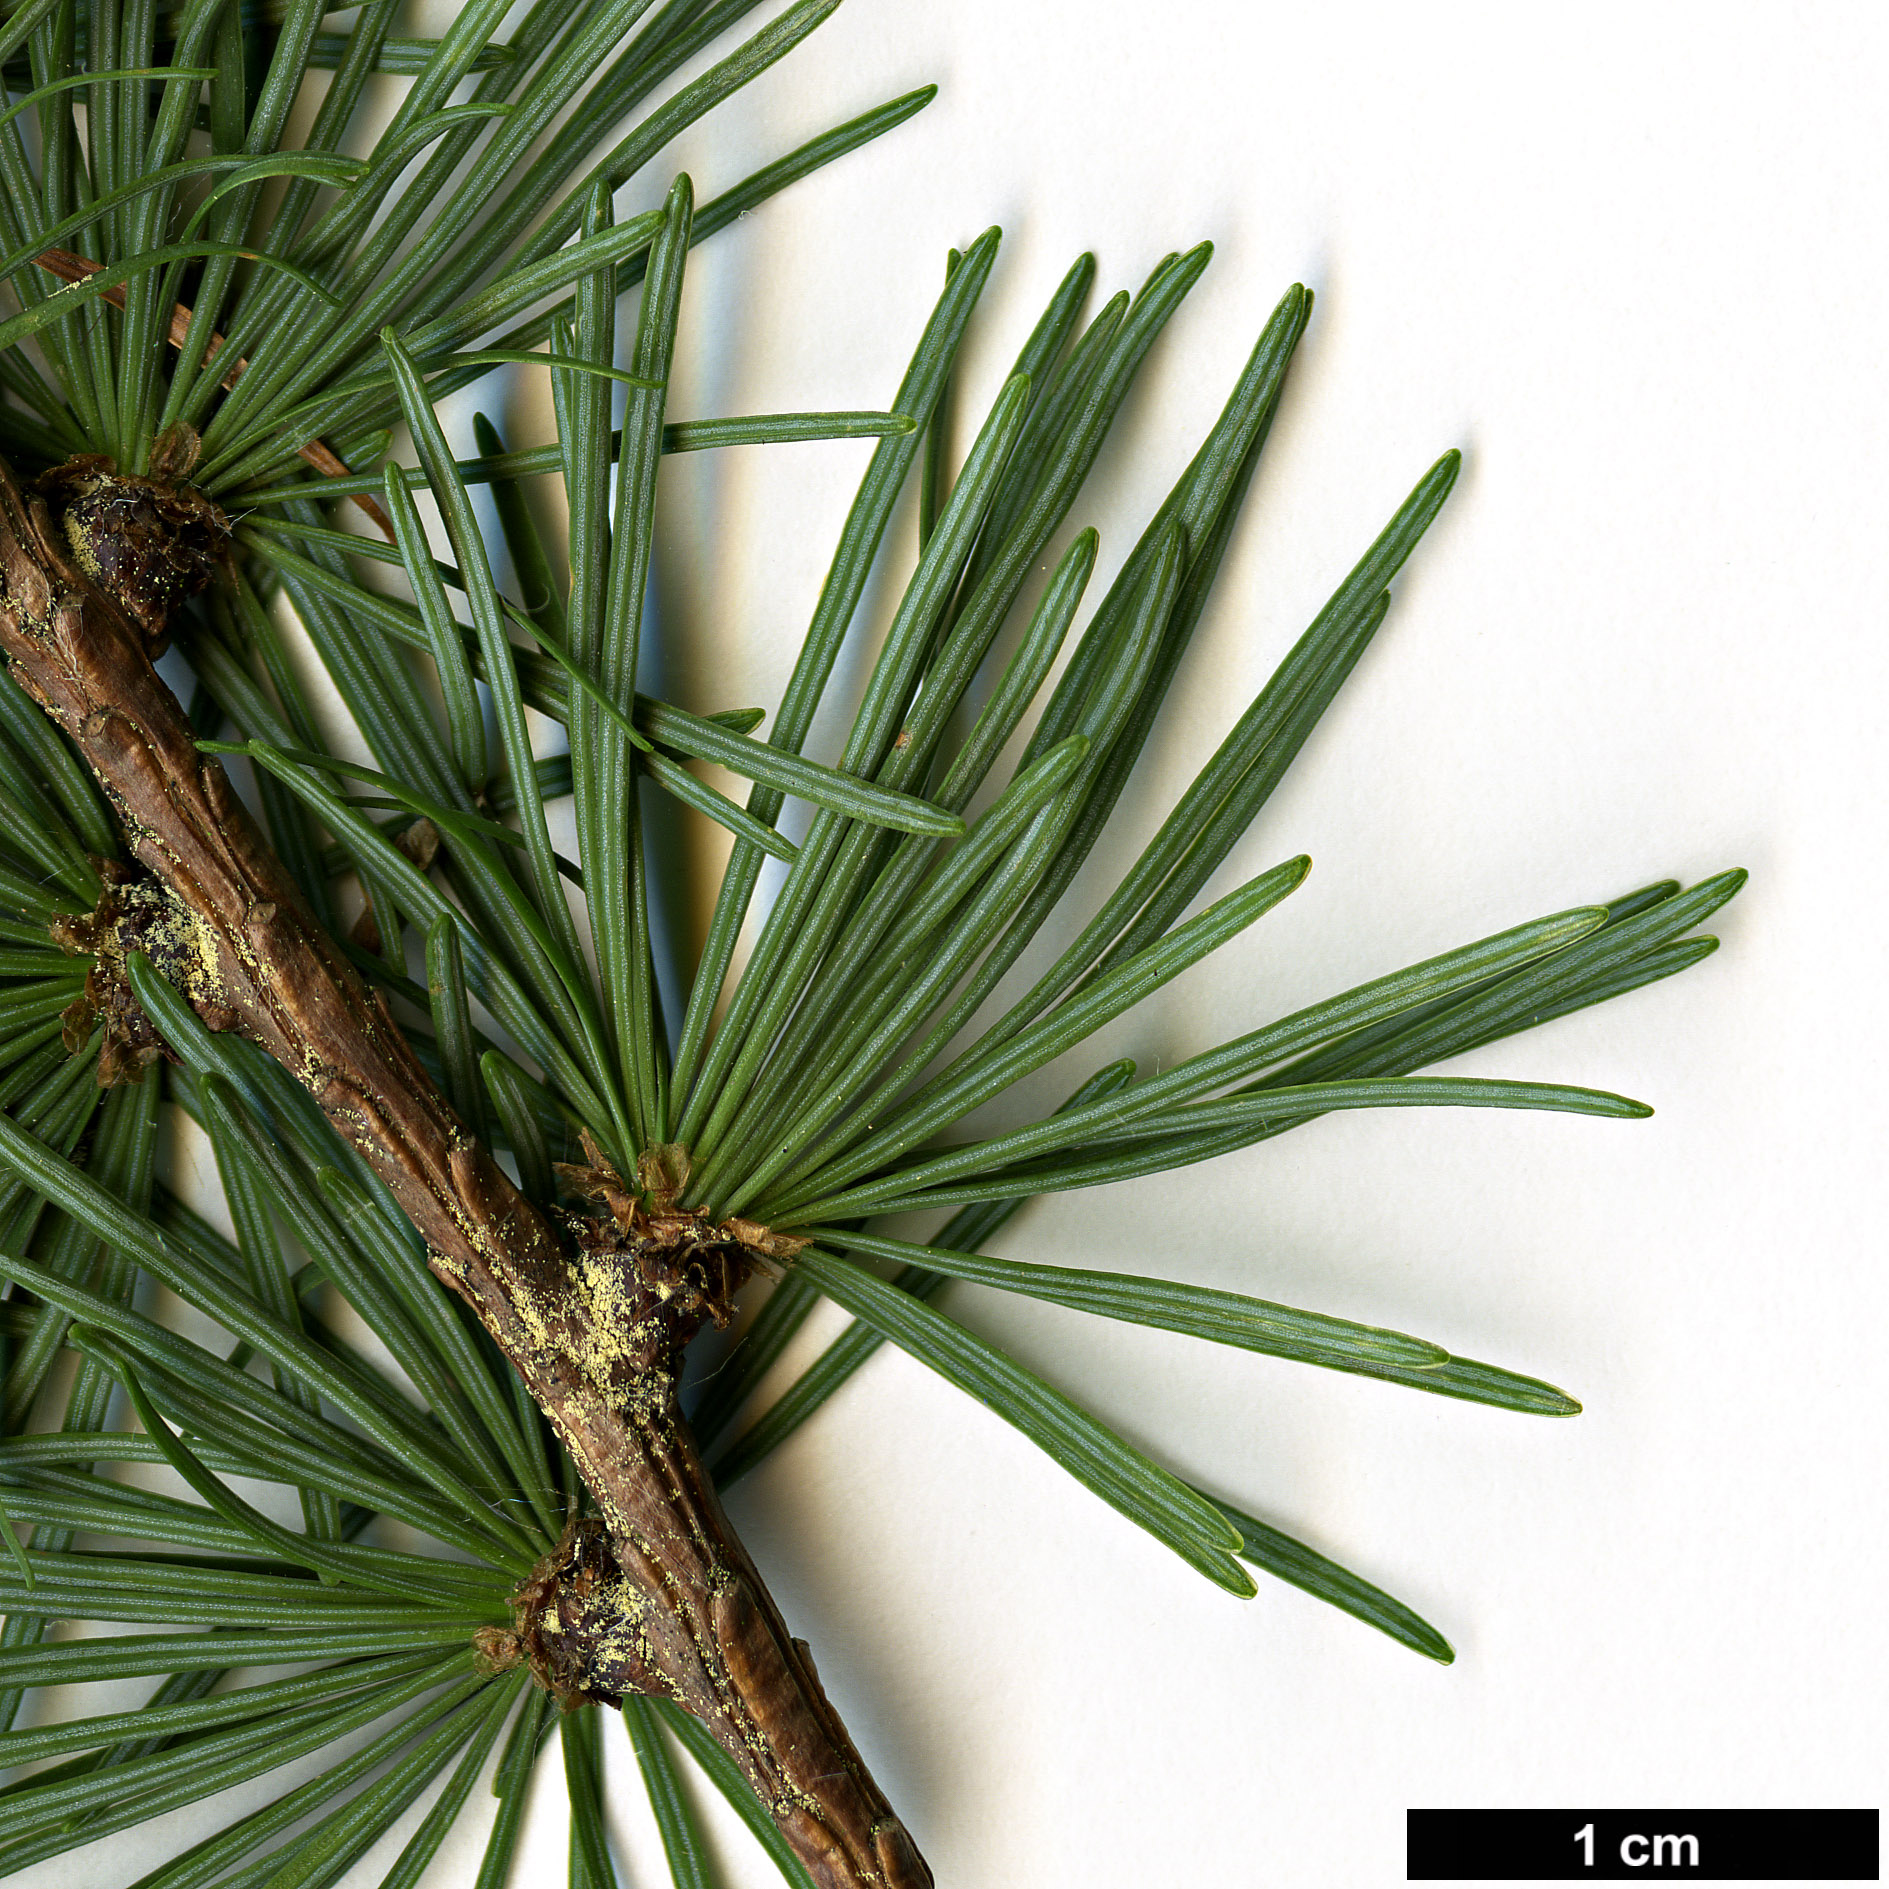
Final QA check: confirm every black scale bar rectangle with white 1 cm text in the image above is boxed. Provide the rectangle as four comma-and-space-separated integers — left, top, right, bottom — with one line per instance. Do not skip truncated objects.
1405, 1810, 1880, 1883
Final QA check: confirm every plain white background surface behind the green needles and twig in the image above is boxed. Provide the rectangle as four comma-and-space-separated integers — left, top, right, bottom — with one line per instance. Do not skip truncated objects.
18, 0, 1889, 1889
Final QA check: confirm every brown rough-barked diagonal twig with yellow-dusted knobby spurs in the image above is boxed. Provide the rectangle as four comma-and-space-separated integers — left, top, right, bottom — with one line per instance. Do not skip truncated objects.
0, 445, 931, 1889
